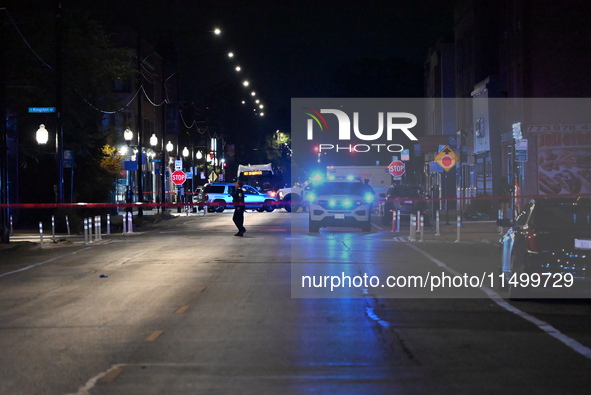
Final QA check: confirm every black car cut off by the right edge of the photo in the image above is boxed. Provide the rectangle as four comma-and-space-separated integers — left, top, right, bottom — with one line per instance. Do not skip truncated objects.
497, 198, 591, 299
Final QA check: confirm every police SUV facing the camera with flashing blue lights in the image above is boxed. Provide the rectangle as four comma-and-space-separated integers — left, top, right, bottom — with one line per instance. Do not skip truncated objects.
305, 179, 374, 232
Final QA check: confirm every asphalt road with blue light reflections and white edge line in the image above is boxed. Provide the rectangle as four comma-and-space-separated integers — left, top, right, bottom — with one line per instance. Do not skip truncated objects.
0, 210, 591, 394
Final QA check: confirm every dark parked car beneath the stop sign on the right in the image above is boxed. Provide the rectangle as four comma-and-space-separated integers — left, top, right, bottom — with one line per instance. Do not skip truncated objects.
381, 184, 431, 226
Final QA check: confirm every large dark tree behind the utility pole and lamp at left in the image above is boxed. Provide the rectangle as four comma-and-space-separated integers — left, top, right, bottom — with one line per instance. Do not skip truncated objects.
6, 2, 135, 202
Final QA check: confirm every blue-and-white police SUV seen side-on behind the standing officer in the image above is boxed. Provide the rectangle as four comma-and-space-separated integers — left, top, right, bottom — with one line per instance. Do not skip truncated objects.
198, 183, 277, 213
